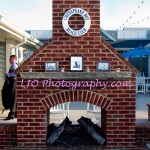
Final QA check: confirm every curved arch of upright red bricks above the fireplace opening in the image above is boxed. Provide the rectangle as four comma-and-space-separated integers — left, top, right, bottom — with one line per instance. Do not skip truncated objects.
40, 90, 112, 110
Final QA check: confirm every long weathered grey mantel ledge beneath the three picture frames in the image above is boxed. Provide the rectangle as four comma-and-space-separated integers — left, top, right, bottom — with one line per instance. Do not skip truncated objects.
20, 72, 132, 81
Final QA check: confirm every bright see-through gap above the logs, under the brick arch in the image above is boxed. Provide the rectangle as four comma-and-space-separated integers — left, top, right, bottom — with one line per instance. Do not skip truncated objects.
49, 102, 101, 126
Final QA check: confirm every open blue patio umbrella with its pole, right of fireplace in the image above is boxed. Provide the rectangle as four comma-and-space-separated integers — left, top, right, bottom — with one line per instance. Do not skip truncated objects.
121, 46, 150, 72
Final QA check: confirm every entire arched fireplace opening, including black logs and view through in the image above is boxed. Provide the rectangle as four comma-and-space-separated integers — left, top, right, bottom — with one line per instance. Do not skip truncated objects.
46, 102, 106, 146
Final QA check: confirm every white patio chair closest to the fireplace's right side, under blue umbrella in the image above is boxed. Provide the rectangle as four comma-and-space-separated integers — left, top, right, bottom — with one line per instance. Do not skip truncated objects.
136, 76, 145, 94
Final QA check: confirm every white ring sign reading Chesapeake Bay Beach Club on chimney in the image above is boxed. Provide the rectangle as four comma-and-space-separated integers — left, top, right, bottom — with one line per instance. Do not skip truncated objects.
62, 8, 91, 37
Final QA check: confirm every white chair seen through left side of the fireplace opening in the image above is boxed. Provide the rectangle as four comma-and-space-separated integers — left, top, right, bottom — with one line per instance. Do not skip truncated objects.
50, 102, 70, 122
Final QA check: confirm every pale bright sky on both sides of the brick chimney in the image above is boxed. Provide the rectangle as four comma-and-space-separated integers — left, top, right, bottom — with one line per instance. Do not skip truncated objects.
0, 0, 150, 30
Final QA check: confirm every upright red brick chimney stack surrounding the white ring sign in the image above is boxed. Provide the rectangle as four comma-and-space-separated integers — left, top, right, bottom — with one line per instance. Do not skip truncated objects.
53, 0, 100, 38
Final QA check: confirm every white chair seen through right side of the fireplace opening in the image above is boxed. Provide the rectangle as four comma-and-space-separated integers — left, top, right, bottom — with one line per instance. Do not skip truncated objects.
86, 103, 101, 126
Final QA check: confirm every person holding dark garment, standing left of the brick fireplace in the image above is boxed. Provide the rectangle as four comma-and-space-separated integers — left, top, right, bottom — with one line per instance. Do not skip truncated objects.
2, 55, 18, 120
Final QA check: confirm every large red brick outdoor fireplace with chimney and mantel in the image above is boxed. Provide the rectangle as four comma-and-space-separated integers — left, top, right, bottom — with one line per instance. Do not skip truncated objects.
16, 0, 137, 146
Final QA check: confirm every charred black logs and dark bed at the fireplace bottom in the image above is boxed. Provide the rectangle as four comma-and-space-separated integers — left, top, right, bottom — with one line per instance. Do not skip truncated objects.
46, 116, 106, 147
